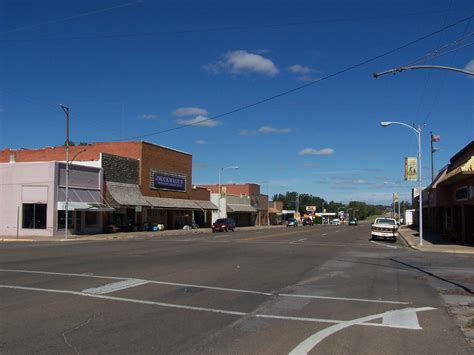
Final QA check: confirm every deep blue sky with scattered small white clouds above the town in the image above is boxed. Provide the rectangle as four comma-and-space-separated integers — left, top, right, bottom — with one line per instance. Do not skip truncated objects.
0, 0, 474, 203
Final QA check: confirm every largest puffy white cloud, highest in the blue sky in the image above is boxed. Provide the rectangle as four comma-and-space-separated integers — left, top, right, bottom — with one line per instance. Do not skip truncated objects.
203, 50, 278, 77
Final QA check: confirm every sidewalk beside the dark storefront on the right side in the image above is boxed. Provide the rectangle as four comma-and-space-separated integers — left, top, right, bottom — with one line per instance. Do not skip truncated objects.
398, 226, 474, 254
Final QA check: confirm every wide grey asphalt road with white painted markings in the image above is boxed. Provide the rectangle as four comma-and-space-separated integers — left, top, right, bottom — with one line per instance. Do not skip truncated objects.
0, 224, 474, 354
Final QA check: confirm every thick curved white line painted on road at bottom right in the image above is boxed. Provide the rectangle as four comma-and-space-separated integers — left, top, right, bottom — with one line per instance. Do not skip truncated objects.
289, 307, 436, 355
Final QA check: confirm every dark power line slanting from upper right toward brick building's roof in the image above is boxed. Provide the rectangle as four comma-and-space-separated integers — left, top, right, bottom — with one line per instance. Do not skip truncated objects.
116, 14, 474, 141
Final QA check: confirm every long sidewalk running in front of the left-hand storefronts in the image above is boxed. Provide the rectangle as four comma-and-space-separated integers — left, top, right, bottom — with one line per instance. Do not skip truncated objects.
0, 225, 285, 243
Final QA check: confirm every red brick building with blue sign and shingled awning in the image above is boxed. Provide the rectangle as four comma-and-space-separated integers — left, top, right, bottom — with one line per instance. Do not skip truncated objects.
0, 141, 217, 234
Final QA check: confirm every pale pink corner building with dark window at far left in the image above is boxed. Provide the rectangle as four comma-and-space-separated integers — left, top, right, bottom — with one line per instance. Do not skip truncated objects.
0, 161, 106, 237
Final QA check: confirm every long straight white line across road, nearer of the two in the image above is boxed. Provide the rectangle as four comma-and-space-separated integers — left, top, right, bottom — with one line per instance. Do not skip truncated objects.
0, 285, 434, 329
